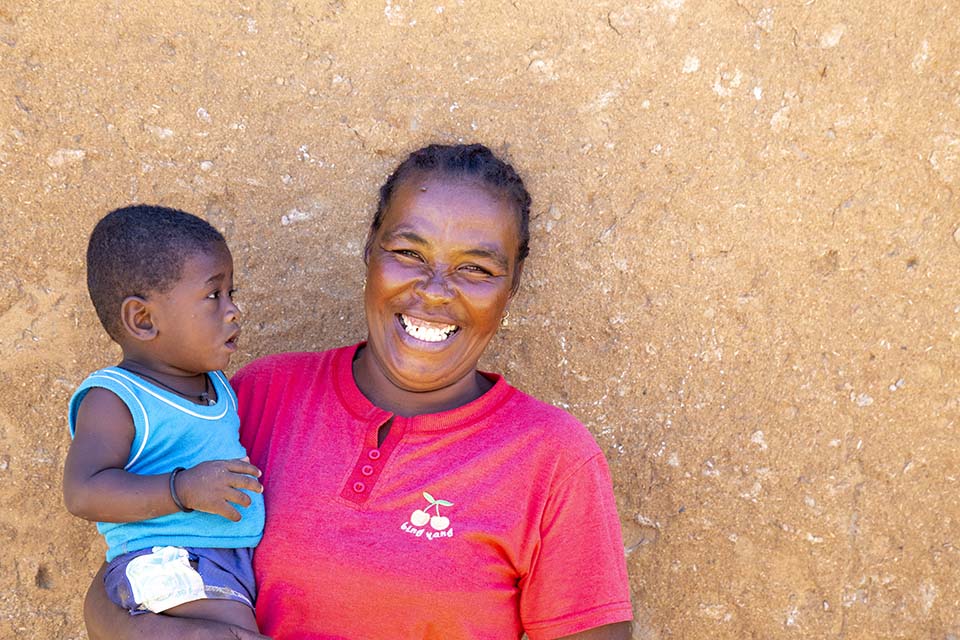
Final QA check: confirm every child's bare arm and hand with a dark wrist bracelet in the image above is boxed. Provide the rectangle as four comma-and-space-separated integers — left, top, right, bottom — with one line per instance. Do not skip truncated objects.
63, 388, 263, 522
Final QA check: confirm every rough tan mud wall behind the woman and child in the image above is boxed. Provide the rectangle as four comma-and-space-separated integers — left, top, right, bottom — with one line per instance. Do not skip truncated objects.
0, 0, 960, 640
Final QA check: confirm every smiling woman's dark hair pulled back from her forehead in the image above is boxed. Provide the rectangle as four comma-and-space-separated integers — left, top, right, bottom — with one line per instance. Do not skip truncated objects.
370, 144, 530, 264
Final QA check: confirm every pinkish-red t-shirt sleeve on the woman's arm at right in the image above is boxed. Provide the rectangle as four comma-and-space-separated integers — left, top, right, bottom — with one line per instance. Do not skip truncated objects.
520, 453, 633, 640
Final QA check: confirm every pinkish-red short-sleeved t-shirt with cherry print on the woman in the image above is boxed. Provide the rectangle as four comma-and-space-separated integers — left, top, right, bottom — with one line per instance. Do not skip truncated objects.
233, 345, 632, 640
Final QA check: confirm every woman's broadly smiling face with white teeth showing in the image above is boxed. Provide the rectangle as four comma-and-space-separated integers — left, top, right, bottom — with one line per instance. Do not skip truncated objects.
364, 175, 520, 392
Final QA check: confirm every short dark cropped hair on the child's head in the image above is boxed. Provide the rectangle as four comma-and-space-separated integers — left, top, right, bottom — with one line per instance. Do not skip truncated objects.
87, 205, 226, 342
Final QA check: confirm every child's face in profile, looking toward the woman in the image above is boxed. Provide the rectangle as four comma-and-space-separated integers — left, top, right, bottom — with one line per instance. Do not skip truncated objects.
148, 244, 240, 373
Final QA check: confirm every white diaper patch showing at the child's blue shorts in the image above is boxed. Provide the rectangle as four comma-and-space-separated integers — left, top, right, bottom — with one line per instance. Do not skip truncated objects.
126, 547, 207, 613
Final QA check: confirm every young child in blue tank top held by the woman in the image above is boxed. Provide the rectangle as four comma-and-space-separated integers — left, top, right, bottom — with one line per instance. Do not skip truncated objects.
63, 206, 264, 631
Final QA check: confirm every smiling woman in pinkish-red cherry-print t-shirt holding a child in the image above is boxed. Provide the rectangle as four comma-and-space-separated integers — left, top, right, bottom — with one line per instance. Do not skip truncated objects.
85, 145, 631, 640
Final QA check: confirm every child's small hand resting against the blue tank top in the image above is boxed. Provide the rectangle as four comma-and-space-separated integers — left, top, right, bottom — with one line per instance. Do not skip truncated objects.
175, 458, 263, 522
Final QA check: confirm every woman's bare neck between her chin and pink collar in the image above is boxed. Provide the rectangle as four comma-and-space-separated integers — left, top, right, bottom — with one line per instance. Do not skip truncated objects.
353, 347, 493, 417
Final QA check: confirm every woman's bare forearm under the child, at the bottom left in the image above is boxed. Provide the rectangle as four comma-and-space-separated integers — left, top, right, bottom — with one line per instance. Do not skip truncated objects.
83, 565, 270, 640
